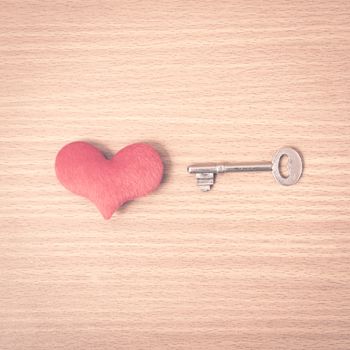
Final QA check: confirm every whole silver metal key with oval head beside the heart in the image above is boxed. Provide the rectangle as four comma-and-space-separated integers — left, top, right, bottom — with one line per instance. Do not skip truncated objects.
187, 147, 303, 192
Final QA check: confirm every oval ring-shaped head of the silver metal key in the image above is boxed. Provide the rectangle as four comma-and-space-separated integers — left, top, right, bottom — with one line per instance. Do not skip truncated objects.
272, 147, 303, 186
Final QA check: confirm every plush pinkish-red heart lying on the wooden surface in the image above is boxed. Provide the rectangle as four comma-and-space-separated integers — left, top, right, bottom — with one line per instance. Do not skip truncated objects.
56, 142, 163, 219
